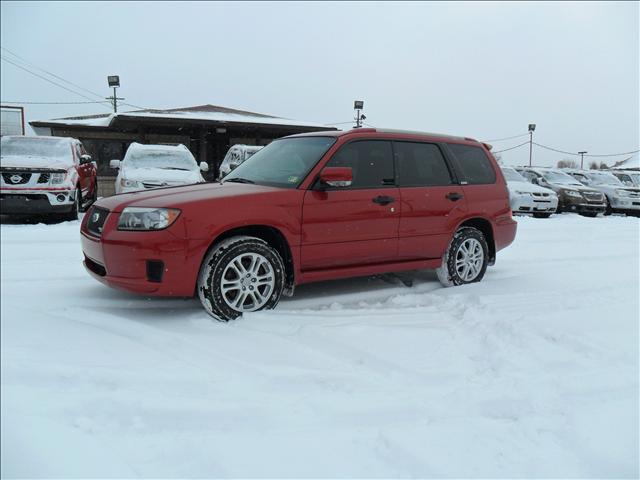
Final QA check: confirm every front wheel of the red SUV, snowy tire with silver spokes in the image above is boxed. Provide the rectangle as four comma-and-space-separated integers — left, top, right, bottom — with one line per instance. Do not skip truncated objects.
197, 236, 285, 322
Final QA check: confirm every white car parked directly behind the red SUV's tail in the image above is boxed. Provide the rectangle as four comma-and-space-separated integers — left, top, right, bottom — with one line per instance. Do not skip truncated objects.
501, 167, 558, 218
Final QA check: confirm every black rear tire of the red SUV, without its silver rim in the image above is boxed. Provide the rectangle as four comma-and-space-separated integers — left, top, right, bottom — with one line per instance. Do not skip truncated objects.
436, 227, 489, 287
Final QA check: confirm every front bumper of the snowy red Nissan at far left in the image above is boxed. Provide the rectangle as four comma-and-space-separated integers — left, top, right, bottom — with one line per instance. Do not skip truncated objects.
0, 189, 76, 215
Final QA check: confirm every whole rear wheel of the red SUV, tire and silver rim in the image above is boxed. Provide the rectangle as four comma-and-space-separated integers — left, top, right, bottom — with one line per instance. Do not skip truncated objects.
436, 227, 489, 287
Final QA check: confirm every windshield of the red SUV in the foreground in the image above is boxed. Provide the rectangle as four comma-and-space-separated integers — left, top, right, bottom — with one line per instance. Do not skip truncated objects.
224, 137, 336, 188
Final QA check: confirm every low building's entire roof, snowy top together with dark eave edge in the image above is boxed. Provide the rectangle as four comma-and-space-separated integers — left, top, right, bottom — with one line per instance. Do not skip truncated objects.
29, 105, 336, 131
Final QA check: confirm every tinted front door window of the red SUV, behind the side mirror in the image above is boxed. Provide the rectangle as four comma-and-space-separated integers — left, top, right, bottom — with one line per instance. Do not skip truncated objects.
326, 140, 395, 189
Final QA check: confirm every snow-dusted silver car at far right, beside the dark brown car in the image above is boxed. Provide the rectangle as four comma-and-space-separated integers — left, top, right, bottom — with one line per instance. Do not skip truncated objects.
566, 169, 640, 215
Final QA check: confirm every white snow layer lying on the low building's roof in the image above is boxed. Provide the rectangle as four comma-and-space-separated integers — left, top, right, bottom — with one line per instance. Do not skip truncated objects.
29, 105, 332, 130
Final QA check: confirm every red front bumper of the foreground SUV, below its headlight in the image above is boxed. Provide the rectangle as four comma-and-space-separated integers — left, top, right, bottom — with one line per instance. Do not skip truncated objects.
80, 212, 208, 297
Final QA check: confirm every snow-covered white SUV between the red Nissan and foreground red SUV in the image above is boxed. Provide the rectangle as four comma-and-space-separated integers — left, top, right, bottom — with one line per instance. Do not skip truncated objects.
110, 143, 209, 193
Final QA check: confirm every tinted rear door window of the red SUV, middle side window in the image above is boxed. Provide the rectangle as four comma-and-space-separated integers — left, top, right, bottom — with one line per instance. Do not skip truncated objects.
393, 142, 452, 187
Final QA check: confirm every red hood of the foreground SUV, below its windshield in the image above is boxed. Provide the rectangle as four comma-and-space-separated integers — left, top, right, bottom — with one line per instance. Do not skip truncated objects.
95, 182, 284, 212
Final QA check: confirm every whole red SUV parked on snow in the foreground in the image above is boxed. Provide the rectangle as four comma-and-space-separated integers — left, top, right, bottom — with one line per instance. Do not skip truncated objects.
81, 128, 516, 320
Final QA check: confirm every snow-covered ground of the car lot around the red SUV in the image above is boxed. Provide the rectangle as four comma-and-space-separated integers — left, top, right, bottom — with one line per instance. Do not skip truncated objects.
1, 214, 640, 478
